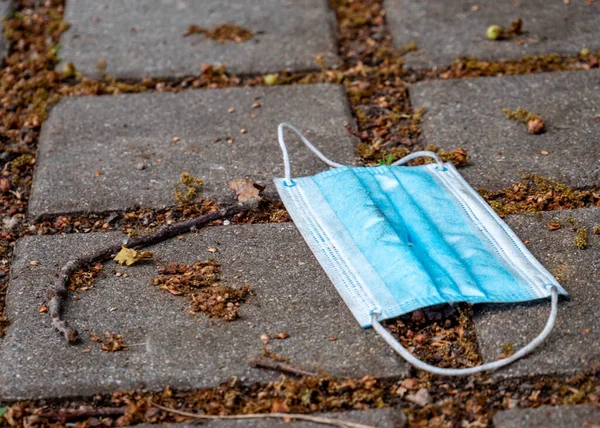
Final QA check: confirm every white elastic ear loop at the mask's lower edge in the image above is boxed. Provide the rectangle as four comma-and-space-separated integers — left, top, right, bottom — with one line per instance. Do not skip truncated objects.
371, 287, 558, 376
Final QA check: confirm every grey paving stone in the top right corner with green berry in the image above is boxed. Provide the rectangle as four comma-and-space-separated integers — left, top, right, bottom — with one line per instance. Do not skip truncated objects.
385, 0, 600, 68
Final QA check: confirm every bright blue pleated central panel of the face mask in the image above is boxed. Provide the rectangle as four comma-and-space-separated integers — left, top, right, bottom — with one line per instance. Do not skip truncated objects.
313, 167, 540, 312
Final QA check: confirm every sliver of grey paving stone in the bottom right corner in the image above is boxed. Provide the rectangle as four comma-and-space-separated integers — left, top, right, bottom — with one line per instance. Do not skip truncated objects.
494, 404, 600, 428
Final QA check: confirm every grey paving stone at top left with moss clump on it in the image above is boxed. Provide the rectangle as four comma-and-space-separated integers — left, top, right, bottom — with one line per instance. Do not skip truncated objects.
60, 0, 338, 79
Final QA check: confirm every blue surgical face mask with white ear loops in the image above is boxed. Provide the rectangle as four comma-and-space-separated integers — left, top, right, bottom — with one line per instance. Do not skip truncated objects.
274, 124, 567, 375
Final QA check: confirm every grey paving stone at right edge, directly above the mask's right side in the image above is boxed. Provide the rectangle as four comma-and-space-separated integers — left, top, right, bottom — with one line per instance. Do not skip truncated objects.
411, 70, 600, 189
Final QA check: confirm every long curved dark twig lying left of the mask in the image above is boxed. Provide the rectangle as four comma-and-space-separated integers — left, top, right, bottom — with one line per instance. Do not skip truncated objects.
48, 199, 257, 343
